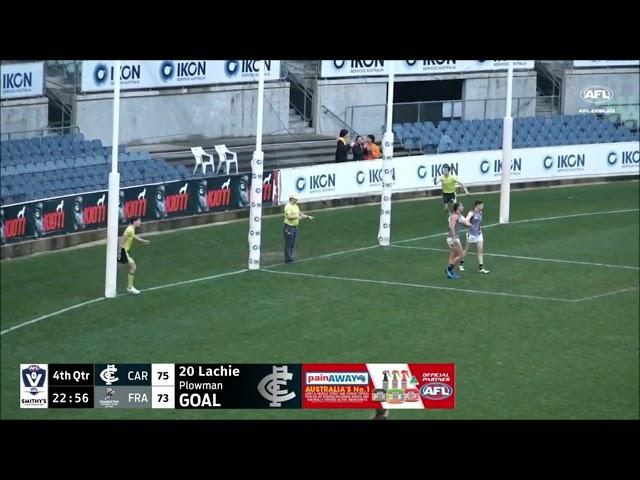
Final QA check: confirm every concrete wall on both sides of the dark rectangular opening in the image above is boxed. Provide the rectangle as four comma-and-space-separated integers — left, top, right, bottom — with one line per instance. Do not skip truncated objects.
314, 70, 536, 136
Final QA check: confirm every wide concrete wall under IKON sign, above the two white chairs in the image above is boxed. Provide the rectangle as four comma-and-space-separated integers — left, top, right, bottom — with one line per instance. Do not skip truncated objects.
72, 81, 289, 145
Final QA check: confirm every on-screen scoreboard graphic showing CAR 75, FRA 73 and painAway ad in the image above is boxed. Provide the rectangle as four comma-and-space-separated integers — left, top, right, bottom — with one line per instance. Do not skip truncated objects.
20, 363, 455, 409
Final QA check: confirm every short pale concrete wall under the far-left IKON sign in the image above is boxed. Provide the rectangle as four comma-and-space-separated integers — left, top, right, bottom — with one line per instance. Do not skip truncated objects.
0, 97, 49, 140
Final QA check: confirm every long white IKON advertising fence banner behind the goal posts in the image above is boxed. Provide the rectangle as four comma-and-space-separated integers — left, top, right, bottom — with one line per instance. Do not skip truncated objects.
277, 142, 640, 203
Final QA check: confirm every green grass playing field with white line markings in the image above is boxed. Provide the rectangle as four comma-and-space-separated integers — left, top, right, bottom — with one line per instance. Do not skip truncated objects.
1, 182, 639, 419
